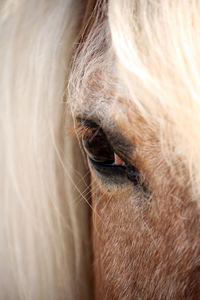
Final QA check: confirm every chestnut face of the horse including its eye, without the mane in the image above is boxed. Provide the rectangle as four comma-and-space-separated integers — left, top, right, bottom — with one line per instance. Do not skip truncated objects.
70, 0, 200, 299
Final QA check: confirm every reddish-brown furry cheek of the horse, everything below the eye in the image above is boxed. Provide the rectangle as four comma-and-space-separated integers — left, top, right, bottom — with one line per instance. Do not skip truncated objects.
91, 172, 200, 300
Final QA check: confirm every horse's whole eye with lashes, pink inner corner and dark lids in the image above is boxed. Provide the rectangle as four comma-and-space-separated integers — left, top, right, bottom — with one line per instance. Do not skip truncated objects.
78, 120, 140, 186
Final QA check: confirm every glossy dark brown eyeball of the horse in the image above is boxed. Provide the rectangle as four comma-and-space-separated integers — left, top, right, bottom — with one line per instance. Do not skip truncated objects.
83, 128, 114, 164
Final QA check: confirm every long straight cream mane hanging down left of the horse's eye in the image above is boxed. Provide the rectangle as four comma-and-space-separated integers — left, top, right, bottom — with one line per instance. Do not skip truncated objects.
0, 0, 91, 300
